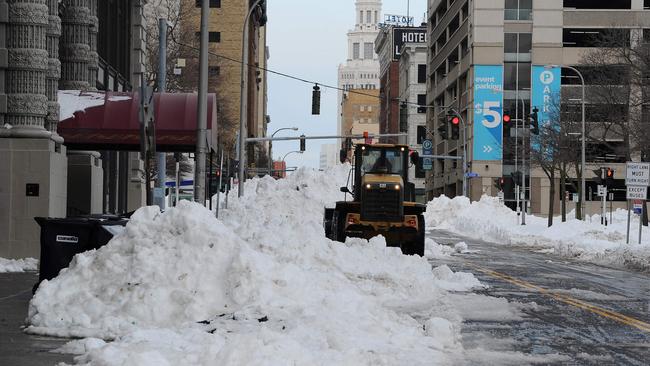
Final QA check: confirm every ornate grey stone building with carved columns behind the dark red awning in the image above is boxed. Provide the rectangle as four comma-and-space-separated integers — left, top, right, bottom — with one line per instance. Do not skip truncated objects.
0, 0, 145, 258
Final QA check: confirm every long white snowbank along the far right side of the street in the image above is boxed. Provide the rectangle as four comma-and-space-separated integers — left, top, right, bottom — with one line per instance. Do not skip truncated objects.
425, 196, 650, 270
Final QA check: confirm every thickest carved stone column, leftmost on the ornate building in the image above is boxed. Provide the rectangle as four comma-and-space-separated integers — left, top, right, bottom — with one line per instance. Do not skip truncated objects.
5, 0, 50, 138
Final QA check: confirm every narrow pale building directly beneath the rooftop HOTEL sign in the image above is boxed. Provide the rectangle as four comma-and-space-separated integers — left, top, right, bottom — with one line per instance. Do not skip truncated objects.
399, 43, 430, 200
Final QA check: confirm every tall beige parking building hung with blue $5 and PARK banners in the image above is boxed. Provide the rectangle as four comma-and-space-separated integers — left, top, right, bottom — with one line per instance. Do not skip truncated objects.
426, 0, 650, 215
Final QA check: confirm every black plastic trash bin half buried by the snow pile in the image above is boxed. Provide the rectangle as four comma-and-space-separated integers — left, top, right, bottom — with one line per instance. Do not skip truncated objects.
33, 215, 128, 292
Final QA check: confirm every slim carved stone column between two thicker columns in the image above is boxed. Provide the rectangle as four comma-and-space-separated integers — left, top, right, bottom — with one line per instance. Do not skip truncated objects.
45, 0, 63, 142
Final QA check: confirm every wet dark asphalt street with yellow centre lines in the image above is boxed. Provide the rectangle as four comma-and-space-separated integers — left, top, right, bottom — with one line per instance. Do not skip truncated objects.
428, 230, 650, 365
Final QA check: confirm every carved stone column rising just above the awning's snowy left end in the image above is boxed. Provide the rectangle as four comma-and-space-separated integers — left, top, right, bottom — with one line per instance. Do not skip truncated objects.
59, 0, 91, 90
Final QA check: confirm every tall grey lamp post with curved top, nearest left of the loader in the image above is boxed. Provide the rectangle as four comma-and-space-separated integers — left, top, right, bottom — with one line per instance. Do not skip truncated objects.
237, 0, 263, 197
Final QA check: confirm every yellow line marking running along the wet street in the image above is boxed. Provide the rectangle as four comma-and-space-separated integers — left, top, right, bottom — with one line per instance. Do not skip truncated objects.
466, 262, 650, 333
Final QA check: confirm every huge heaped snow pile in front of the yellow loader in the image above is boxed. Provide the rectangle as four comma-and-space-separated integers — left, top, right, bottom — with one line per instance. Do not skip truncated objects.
28, 166, 496, 365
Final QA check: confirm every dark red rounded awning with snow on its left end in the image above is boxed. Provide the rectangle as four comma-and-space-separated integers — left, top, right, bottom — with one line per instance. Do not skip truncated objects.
58, 92, 217, 152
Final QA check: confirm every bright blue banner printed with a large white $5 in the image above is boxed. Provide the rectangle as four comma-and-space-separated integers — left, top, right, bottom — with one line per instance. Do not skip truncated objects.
473, 65, 503, 161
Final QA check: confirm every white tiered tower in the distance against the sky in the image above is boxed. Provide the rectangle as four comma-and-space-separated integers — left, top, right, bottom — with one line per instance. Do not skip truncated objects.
337, 0, 381, 135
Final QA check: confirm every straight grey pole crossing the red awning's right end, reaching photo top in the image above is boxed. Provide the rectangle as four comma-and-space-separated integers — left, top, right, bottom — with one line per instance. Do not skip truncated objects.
194, 0, 209, 206
